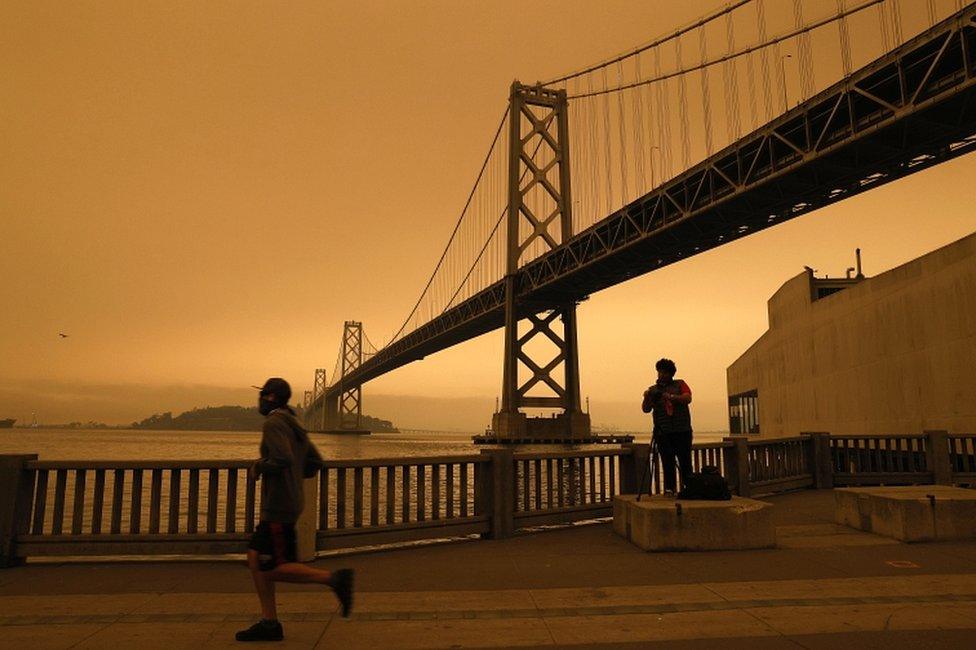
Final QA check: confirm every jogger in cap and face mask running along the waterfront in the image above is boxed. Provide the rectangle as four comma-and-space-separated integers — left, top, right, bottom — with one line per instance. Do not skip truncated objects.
237, 377, 353, 641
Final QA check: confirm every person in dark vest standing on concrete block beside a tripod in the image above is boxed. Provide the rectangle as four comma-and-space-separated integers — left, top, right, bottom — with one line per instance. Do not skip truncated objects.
641, 359, 692, 494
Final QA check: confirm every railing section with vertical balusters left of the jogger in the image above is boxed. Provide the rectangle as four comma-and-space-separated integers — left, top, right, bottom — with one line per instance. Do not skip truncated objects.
11, 460, 257, 555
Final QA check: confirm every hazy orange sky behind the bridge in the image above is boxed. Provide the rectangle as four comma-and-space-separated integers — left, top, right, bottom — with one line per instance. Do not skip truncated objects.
0, 0, 976, 429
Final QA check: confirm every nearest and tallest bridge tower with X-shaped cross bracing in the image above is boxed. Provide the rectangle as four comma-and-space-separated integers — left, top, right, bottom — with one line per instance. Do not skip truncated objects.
492, 81, 590, 440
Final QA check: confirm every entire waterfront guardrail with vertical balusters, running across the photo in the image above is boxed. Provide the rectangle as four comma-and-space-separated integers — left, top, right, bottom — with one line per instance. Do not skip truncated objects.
0, 431, 976, 565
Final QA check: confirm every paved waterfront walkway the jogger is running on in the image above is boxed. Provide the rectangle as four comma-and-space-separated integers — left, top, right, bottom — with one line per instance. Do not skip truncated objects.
0, 491, 976, 649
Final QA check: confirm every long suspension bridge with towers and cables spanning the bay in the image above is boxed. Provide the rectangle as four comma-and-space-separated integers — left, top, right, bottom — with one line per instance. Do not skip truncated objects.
305, 0, 976, 439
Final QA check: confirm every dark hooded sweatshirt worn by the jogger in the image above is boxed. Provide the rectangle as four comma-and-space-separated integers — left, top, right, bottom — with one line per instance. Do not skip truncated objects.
256, 408, 322, 523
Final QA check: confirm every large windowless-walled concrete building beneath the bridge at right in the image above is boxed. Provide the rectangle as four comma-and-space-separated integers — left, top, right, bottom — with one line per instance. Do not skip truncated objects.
728, 233, 976, 437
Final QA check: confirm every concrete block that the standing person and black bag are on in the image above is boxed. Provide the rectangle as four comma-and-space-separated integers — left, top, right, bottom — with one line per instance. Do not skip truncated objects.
613, 494, 776, 551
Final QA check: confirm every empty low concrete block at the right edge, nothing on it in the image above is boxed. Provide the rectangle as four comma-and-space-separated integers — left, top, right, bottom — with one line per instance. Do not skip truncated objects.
834, 485, 976, 542
